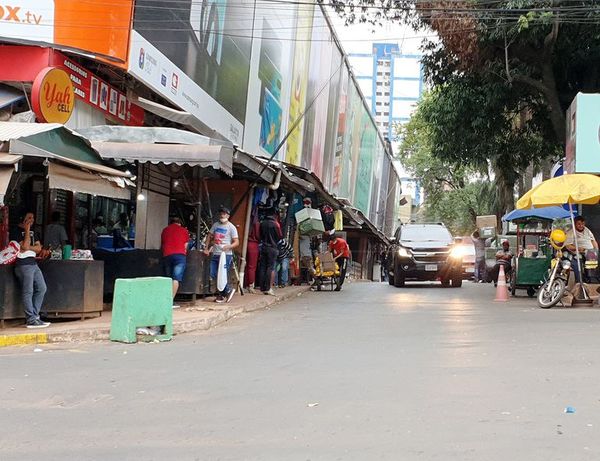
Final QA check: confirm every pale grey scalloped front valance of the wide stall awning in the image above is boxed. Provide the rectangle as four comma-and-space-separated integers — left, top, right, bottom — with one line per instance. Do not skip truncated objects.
92, 142, 233, 176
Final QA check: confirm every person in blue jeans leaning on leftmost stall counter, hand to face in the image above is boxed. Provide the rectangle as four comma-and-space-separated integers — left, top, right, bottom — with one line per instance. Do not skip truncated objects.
15, 213, 50, 328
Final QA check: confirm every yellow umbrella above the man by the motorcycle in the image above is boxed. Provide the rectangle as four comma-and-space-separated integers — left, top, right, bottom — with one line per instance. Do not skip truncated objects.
517, 174, 600, 210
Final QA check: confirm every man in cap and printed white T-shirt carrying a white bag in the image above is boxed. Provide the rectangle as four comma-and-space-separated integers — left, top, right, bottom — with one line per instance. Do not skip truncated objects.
204, 207, 240, 303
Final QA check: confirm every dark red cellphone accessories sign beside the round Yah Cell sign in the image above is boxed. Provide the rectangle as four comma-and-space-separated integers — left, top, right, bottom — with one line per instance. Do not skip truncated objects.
51, 52, 144, 126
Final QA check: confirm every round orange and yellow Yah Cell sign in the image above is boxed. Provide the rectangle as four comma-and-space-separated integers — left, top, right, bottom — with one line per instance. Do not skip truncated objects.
31, 67, 75, 123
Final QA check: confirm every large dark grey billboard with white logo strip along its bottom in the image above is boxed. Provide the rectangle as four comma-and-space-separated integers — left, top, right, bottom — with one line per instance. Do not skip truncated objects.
129, 0, 251, 144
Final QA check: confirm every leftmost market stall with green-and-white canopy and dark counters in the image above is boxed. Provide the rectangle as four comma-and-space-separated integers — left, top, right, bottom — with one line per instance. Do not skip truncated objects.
0, 122, 134, 321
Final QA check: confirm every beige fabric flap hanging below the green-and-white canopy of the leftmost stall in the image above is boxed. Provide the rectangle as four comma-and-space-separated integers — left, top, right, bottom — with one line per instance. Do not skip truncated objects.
48, 162, 131, 200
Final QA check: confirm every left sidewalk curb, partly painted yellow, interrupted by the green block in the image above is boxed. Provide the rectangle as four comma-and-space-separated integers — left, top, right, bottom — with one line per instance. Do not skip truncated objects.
0, 286, 309, 348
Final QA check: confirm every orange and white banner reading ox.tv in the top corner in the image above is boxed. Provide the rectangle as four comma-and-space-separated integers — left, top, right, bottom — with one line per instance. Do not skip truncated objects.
0, 0, 133, 66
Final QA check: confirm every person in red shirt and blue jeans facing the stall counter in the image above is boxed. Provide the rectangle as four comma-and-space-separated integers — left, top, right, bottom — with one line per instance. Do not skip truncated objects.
160, 217, 190, 298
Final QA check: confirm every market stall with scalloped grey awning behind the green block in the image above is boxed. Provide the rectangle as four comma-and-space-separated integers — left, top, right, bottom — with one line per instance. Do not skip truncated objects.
75, 126, 290, 298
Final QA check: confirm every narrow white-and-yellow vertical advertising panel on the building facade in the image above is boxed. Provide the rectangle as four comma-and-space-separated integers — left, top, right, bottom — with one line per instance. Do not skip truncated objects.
285, 4, 314, 165
